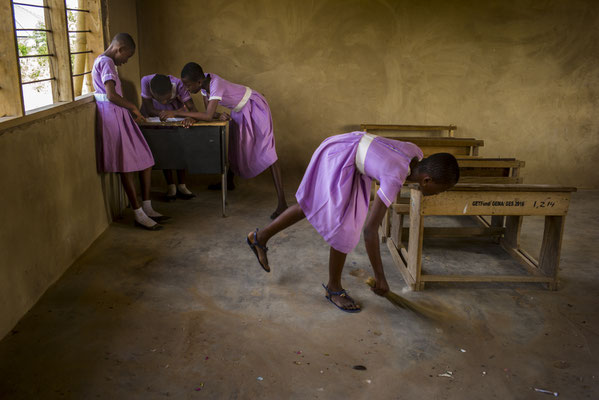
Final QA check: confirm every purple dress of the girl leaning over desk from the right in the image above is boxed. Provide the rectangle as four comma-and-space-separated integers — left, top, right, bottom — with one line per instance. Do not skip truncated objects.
201, 74, 278, 179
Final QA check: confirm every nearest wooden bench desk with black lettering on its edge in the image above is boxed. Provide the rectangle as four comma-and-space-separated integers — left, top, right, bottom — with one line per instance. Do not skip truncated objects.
386, 184, 576, 290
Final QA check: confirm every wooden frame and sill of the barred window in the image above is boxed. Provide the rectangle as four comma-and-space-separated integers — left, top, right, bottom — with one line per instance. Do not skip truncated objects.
0, 0, 104, 130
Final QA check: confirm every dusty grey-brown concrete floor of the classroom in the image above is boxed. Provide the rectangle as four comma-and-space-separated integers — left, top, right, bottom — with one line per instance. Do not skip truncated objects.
0, 177, 599, 399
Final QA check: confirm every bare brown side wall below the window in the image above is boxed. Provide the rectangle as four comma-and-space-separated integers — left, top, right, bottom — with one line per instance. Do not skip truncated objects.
0, 102, 110, 338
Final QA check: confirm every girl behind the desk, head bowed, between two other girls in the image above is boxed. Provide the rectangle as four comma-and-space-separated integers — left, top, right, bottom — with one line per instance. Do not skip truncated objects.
141, 74, 196, 201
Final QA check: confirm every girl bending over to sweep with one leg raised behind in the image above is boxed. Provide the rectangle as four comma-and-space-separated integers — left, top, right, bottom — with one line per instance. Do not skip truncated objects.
247, 132, 459, 312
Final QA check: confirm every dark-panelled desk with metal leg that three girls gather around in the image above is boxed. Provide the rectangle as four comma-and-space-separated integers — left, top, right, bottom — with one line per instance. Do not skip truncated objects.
139, 121, 228, 217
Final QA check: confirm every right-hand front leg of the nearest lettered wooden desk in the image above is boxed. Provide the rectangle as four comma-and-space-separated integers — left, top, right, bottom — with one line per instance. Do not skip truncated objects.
539, 215, 566, 290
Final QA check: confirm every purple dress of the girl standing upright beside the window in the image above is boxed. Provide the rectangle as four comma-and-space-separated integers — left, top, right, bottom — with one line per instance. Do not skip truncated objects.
92, 55, 154, 172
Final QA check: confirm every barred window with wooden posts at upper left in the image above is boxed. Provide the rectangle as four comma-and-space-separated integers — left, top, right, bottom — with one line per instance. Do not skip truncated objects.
0, 0, 104, 118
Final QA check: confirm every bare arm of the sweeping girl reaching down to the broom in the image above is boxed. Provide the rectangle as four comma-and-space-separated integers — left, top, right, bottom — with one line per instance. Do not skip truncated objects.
364, 195, 389, 296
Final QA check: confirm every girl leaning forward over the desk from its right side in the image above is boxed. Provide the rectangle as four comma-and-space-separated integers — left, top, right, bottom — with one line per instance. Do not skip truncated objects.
161, 63, 287, 219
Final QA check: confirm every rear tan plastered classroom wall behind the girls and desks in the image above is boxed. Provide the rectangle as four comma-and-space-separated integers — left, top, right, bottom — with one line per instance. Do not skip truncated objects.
137, 0, 599, 188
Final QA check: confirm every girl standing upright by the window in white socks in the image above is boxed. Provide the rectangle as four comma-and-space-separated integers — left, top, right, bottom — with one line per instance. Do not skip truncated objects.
92, 33, 168, 230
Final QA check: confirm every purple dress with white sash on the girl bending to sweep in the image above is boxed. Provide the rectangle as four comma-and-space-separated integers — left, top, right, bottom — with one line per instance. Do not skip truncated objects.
295, 132, 423, 254
